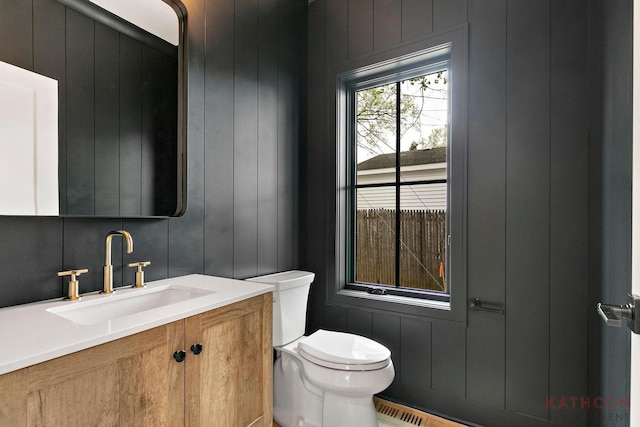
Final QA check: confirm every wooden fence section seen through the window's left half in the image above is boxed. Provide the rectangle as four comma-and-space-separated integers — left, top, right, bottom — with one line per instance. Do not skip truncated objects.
355, 201, 396, 285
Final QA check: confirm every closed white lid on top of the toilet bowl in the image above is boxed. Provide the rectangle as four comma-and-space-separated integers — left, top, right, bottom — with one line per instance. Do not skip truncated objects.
298, 329, 391, 365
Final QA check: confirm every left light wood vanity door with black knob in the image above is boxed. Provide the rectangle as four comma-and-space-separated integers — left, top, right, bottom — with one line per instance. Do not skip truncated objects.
26, 321, 184, 427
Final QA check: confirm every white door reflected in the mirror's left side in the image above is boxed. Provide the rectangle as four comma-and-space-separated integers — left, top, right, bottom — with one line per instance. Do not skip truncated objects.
0, 61, 59, 216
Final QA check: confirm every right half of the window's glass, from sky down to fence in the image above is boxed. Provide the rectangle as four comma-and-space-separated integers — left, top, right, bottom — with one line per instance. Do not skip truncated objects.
398, 70, 449, 292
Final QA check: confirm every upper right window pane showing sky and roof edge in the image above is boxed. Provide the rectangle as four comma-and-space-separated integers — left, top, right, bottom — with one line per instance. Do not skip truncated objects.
400, 70, 449, 182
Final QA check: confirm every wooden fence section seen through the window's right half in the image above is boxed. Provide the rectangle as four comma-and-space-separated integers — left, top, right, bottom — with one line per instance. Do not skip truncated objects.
399, 192, 448, 292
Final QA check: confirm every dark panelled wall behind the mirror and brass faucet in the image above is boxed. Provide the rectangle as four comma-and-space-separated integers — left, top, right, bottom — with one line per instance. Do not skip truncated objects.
0, 0, 305, 307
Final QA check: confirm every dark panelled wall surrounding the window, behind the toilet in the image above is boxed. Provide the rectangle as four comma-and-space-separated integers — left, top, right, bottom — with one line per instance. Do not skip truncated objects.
302, 0, 631, 426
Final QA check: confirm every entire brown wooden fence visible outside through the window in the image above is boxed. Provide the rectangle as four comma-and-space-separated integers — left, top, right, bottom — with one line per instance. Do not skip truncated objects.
355, 209, 447, 291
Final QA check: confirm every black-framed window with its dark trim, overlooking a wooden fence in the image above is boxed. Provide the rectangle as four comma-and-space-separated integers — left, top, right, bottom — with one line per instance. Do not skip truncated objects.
329, 27, 466, 319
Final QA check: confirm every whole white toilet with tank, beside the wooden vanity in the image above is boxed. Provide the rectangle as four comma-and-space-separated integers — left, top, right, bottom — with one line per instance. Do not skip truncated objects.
247, 270, 395, 427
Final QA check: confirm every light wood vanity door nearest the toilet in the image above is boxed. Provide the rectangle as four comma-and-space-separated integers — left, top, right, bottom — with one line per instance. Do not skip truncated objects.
185, 293, 273, 427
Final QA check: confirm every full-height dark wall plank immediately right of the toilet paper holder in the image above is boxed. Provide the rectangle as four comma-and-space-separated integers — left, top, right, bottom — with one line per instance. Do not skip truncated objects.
506, 0, 550, 419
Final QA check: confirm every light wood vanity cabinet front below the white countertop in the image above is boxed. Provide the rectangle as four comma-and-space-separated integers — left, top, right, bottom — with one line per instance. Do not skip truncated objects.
0, 293, 273, 427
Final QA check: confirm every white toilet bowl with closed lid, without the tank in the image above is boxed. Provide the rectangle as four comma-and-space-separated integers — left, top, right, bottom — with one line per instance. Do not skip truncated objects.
273, 329, 395, 427
